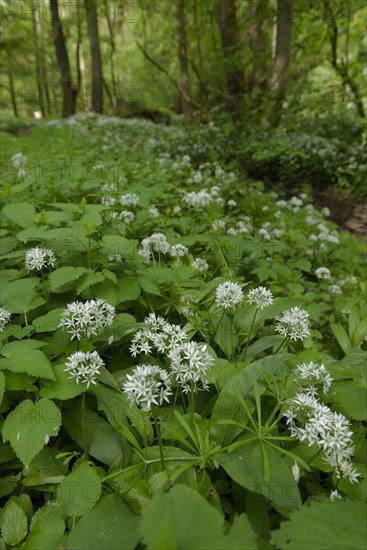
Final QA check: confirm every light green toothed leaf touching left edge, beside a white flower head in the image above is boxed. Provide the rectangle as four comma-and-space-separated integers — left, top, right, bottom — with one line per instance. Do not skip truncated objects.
0, 340, 55, 380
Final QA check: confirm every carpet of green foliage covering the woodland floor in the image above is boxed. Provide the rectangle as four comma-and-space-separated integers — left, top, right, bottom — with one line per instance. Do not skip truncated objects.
0, 115, 367, 550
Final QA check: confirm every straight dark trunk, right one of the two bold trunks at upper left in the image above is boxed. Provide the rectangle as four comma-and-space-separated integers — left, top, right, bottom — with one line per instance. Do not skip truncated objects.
84, 0, 103, 113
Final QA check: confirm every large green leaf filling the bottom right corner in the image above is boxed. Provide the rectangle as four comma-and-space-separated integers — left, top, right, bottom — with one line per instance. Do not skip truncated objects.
272, 499, 367, 550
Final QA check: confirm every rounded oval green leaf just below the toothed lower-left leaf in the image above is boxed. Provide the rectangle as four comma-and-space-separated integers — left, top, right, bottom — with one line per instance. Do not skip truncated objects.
57, 462, 101, 517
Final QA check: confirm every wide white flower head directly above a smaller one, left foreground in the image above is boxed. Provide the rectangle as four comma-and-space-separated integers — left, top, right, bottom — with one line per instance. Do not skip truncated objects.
58, 298, 115, 340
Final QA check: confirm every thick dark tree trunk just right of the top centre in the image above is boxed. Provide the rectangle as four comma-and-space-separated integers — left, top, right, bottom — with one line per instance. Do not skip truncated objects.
218, 0, 245, 113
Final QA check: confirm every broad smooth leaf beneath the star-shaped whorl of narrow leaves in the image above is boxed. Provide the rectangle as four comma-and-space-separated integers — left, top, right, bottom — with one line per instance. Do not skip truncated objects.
216, 440, 301, 514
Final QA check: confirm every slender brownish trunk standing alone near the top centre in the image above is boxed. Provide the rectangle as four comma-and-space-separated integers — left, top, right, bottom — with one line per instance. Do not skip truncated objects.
176, 0, 192, 124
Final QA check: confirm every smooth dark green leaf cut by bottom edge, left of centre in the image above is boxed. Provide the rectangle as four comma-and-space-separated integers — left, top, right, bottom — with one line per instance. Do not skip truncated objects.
66, 495, 141, 550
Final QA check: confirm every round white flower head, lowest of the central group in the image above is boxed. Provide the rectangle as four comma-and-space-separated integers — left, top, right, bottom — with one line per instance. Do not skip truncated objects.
122, 365, 172, 412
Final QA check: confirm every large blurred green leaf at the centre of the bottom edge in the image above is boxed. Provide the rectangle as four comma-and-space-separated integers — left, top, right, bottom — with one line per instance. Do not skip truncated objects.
141, 485, 257, 550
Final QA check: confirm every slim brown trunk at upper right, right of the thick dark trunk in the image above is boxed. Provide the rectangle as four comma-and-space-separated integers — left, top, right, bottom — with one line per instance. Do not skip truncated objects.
270, 0, 292, 126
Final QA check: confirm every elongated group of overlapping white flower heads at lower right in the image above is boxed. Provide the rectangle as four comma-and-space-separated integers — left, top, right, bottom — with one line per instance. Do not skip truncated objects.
284, 374, 360, 483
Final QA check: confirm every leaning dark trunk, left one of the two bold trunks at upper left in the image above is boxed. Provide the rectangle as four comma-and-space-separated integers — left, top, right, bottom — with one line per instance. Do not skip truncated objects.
50, 0, 75, 117
